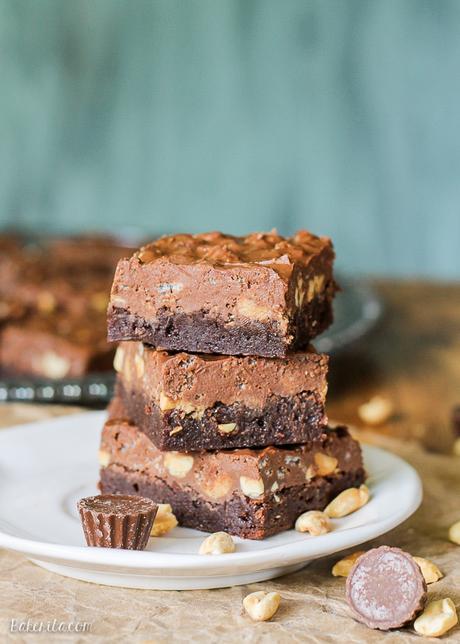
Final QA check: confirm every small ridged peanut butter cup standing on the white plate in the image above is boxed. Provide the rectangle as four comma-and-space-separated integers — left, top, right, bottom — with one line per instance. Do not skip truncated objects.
78, 494, 158, 550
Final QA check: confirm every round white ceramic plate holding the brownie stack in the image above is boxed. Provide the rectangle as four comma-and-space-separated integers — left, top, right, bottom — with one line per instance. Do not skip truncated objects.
0, 412, 422, 590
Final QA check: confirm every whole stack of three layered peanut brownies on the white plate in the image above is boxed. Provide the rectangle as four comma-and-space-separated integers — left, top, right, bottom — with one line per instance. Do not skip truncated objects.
100, 231, 364, 539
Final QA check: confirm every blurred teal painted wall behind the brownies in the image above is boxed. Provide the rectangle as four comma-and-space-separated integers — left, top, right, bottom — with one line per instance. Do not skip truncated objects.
0, 0, 460, 278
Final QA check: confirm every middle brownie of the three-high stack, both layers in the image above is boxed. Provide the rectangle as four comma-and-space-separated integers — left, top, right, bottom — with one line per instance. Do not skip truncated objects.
114, 342, 328, 451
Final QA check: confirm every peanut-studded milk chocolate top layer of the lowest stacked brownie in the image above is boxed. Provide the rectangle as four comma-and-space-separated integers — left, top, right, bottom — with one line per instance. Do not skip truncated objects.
100, 419, 363, 503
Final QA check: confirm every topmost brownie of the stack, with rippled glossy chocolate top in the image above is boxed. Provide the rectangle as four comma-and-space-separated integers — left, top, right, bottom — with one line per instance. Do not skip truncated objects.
108, 231, 336, 357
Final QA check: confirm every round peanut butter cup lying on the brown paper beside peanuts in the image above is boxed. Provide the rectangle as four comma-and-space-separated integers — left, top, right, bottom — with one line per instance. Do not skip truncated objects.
346, 546, 426, 631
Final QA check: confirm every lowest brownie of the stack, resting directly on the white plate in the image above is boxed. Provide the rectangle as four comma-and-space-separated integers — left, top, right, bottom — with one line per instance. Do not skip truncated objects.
99, 402, 365, 539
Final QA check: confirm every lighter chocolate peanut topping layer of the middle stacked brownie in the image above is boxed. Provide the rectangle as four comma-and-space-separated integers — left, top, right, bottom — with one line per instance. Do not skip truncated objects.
115, 342, 328, 412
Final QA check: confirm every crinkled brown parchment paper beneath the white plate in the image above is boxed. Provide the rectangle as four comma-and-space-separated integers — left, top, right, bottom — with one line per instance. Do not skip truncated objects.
0, 405, 460, 644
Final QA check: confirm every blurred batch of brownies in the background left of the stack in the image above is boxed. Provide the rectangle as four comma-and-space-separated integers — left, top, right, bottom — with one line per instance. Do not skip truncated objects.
0, 235, 129, 379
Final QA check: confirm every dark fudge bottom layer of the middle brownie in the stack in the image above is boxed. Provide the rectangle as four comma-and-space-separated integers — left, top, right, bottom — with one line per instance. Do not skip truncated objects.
117, 381, 327, 452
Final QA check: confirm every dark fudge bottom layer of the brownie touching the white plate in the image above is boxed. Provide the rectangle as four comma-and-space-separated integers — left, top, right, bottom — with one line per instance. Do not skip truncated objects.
99, 465, 365, 539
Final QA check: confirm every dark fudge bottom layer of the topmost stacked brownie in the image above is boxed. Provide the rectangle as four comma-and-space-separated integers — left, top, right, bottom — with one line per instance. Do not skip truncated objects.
108, 294, 335, 358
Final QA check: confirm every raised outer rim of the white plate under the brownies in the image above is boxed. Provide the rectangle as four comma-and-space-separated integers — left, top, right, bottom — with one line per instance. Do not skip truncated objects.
0, 411, 423, 577
